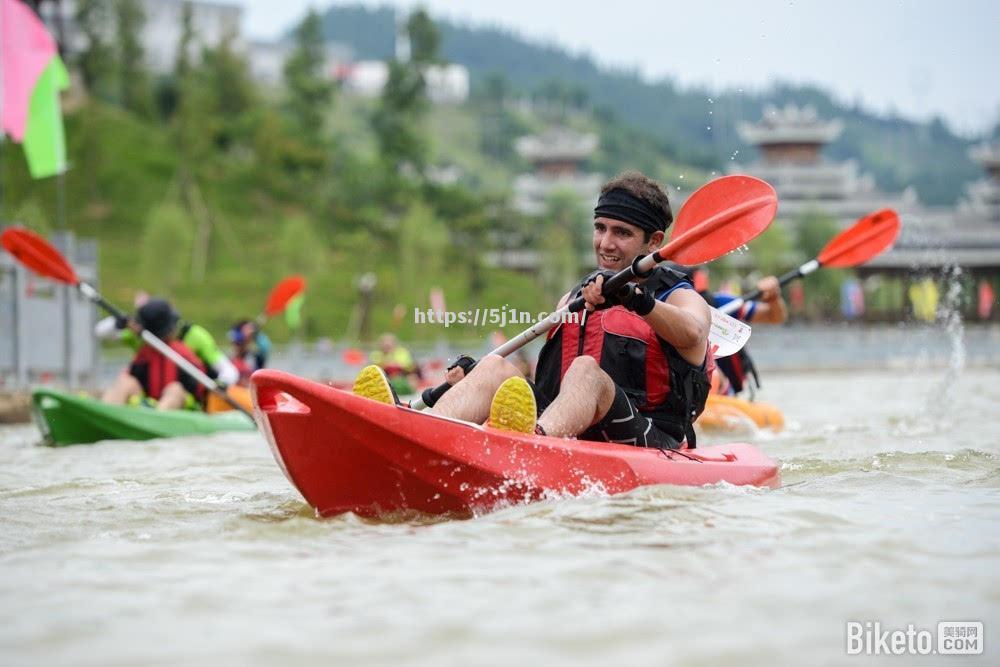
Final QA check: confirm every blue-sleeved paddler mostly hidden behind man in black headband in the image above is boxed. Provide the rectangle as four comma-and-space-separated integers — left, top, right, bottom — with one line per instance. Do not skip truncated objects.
692, 265, 788, 397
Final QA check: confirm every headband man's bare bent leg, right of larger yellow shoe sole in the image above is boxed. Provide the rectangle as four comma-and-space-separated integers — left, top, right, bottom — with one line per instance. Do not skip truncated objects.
538, 356, 615, 438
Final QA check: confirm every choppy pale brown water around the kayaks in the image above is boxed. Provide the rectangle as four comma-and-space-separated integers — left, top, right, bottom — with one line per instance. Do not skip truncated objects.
0, 370, 1000, 665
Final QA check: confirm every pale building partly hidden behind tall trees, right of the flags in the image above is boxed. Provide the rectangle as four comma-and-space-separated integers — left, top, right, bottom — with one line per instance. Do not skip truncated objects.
41, 0, 245, 74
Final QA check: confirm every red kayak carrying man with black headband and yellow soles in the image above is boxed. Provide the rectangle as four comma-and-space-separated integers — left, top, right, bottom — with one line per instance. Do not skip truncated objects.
251, 370, 781, 516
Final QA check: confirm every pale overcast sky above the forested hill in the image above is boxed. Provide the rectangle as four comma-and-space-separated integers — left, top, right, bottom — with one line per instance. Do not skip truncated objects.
240, 0, 1000, 134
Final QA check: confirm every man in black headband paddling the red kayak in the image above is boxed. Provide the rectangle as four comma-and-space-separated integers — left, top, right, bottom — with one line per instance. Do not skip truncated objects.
356, 171, 713, 448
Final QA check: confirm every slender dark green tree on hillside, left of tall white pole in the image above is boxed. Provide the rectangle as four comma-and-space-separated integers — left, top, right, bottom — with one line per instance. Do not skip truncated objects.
284, 10, 333, 142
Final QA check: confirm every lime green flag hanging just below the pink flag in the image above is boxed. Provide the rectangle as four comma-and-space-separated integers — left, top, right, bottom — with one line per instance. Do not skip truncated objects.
24, 56, 69, 178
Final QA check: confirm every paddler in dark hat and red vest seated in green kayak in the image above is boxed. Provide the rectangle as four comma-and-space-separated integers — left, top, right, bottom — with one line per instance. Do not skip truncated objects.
102, 299, 205, 410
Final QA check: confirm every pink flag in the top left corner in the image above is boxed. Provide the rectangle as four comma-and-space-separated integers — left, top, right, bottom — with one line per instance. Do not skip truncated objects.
0, 0, 56, 142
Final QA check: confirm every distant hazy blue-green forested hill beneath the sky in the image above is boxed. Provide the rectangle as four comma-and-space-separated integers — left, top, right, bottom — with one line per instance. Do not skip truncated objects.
314, 6, 985, 204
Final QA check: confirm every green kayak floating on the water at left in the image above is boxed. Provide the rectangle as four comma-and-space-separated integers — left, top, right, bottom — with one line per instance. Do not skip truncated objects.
31, 389, 256, 446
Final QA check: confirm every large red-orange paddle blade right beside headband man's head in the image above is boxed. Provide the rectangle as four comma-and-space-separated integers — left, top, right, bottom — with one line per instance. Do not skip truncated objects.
657, 175, 778, 264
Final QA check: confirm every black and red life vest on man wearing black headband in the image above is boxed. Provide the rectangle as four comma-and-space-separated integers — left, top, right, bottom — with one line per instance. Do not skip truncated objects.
535, 268, 714, 447
